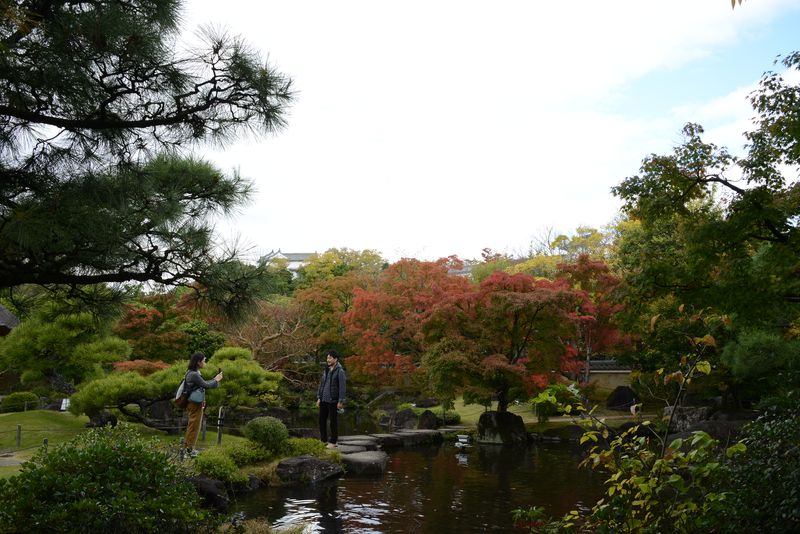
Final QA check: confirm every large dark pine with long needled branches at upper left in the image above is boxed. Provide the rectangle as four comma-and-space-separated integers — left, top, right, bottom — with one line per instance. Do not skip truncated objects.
0, 0, 292, 312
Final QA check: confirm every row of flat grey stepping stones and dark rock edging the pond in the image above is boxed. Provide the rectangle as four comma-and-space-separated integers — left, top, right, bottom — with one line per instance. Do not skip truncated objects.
275, 427, 468, 484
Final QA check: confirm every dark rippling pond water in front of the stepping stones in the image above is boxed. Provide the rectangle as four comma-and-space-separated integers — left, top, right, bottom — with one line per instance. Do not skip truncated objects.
234, 444, 603, 533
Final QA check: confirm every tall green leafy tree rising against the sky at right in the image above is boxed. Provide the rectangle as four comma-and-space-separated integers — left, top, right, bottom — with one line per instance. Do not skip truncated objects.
613, 53, 800, 402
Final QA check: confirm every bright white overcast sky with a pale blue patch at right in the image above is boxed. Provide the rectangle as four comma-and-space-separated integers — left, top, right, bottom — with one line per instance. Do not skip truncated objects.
184, 0, 800, 261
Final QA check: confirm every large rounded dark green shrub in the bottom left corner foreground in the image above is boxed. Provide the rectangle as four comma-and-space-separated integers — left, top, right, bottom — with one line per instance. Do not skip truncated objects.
0, 425, 219, 533
